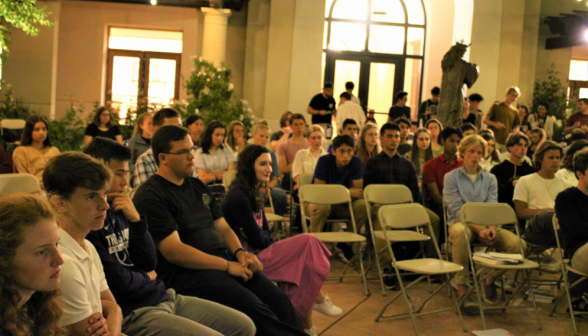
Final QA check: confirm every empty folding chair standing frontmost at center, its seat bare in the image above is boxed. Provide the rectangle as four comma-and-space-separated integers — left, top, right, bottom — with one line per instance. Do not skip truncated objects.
376, 204, 467, 336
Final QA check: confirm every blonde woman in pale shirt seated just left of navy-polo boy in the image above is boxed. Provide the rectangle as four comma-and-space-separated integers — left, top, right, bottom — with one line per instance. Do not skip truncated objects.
292, 125, 327, 190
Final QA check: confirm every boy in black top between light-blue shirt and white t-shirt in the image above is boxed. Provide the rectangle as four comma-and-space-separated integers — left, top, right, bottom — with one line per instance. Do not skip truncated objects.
490, 133, 535, 209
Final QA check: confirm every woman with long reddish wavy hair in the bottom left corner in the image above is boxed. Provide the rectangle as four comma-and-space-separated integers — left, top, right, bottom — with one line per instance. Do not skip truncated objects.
0, 194, 66, 336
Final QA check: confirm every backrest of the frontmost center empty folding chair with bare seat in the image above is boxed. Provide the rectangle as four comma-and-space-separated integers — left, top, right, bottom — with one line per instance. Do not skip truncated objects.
378, 203, 429, 229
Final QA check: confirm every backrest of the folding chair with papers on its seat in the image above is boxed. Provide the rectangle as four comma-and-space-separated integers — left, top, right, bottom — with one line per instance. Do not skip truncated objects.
461, 202, 518, 226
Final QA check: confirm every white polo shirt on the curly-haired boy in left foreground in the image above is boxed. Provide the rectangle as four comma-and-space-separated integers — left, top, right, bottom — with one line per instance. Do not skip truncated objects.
59, 229, 108, 326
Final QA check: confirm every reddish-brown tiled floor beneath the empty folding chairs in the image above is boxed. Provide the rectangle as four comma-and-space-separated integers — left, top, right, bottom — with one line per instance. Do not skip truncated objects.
313, 261, 588, 336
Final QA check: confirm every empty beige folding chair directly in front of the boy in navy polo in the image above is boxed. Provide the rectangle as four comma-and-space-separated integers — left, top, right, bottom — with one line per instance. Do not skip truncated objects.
299, 184, 369, 295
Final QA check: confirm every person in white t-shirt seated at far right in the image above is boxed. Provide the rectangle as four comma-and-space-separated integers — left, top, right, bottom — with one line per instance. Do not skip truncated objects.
513, 140, 574, 246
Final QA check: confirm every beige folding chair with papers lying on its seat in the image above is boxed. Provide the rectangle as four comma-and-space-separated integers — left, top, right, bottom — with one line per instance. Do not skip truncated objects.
461, 202, 542, 330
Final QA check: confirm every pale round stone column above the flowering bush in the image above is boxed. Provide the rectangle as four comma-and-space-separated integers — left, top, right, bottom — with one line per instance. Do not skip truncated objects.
201, 7, 231, 66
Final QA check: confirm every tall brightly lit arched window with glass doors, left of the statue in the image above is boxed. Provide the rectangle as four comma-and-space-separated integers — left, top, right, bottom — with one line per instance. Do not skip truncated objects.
323, 0, 426, 124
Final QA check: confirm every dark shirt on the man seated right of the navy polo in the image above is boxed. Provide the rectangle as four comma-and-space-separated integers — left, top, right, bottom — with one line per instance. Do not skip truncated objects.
363, 151, 419, 202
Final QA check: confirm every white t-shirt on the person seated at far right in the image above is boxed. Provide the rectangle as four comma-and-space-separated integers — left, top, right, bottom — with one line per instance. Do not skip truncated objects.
512, 173, 574, 209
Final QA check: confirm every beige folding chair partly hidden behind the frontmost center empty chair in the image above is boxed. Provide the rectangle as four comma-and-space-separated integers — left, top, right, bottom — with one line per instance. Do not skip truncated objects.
363, 184, 412, 296
